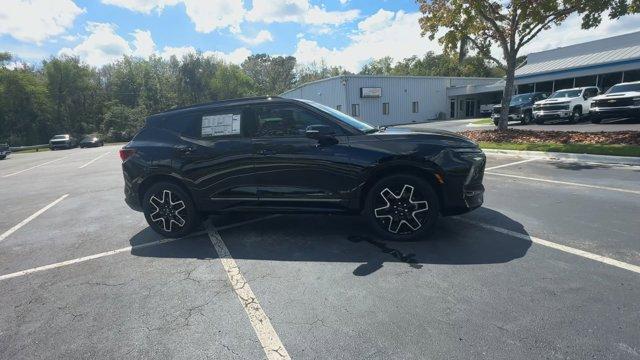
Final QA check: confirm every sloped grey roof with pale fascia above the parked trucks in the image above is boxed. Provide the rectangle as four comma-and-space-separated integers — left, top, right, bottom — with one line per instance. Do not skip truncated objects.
516, 31, 640, 78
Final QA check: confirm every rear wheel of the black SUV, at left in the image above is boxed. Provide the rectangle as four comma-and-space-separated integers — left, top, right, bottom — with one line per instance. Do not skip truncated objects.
142, 181, 200, 238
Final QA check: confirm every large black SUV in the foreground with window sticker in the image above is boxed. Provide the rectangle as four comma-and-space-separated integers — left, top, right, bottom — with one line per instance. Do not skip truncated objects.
120, 97, 485, 240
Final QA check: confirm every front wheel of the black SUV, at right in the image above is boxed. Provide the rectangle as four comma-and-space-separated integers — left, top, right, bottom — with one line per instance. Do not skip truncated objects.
363, 174, 440, 241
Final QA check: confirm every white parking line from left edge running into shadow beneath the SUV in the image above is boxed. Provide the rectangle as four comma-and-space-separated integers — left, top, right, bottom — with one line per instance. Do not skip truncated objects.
0, 214, 278, 281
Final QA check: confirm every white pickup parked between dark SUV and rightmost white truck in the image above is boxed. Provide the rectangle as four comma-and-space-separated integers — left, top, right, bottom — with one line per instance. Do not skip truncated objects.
533, 86, 600, 124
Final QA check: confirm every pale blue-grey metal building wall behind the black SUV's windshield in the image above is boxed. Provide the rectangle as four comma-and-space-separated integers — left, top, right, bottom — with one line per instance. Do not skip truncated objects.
281, 75, 500, 125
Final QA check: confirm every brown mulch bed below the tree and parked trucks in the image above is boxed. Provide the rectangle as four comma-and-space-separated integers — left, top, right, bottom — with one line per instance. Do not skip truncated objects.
460, 129, 640, 146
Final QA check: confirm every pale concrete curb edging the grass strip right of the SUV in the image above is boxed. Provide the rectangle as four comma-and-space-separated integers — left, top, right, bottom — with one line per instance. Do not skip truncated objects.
482, 149, 640, 166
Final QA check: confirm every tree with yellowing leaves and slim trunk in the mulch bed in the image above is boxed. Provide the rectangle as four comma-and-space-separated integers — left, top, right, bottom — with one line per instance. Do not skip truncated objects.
417, 0, 640, 130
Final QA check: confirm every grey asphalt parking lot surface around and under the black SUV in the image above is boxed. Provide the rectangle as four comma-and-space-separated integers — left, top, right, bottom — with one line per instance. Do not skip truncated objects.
0, 146, 640, 359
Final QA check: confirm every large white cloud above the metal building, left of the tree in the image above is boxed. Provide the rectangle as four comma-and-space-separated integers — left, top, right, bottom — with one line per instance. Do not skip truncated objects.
294, 9, 440, 72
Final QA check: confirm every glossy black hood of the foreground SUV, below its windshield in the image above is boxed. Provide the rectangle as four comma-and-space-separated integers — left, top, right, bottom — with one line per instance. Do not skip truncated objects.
369, 127, 478, 147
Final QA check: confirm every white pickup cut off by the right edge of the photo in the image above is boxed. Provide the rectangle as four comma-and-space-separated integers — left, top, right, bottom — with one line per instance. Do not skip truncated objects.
591, 81, 640, 124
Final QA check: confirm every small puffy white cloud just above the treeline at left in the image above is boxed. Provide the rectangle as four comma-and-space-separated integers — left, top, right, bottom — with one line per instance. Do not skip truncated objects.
59, 22, 132, 66
